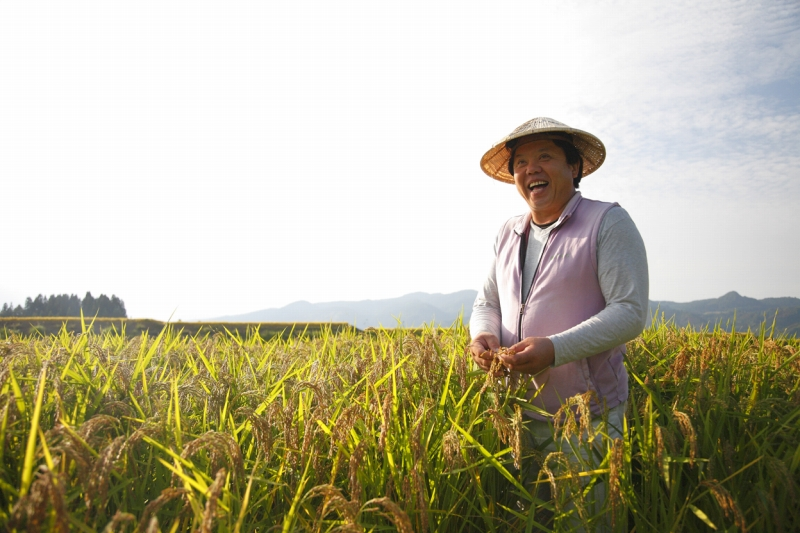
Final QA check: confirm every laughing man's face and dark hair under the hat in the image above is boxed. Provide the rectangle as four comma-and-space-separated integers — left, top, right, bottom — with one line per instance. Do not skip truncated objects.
514, 140, 579, 224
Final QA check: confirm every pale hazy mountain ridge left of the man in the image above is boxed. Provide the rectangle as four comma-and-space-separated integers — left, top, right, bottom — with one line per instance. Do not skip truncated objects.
214, 290, 478, 329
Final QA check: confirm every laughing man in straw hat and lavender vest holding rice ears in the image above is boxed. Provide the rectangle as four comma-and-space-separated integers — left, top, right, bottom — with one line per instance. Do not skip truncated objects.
470, 118, 648, 528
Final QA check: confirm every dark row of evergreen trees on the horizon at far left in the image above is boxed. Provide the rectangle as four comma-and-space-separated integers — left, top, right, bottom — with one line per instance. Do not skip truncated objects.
0, 292, 128, 318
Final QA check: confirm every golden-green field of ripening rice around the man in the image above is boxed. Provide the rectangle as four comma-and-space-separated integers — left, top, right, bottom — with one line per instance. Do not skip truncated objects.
0, 318, 800, 532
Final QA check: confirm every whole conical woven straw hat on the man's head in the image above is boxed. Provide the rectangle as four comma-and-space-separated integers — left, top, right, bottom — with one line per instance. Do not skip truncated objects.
481, 117, 606, 183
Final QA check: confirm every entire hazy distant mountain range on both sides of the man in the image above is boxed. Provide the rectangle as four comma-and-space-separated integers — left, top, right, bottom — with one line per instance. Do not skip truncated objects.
214, 290, 800, 335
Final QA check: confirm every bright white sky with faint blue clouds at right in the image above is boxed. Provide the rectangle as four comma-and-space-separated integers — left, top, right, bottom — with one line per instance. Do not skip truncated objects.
0, 0, 800, 320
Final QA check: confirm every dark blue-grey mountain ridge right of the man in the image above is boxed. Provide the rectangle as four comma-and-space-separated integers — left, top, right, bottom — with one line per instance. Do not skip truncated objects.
650, 291, 800, 335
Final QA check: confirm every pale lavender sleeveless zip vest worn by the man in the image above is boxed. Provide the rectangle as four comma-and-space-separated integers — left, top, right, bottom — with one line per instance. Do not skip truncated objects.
496, 192, 628, 420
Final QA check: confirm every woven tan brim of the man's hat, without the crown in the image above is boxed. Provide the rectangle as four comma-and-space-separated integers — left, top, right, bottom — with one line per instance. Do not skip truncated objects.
481, 127, 606, 183
